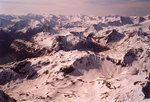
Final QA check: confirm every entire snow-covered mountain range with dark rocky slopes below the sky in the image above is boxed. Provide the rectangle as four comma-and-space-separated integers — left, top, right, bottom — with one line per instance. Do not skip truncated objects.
0, 14, 150, 102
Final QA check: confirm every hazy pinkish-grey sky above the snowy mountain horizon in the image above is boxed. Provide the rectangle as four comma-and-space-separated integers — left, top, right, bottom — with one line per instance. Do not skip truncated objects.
0, 0, 150, 16
